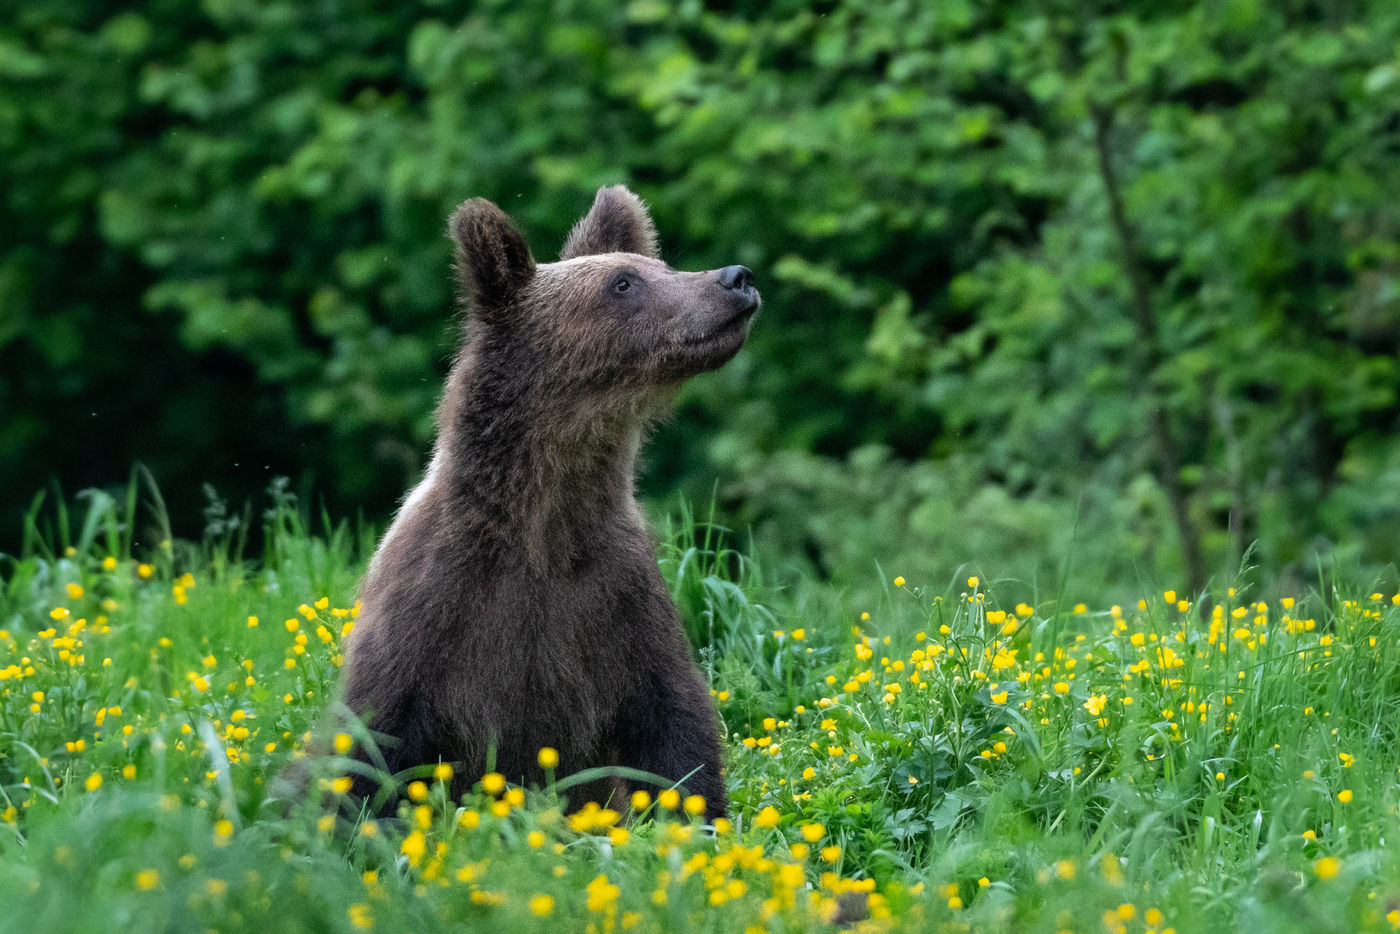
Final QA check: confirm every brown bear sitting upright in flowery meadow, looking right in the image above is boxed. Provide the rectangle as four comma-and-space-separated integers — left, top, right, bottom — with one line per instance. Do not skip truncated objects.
334, 186, 759, 819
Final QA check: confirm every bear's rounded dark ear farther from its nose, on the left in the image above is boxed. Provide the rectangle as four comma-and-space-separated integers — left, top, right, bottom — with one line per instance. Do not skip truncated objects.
447, 197, 535, 312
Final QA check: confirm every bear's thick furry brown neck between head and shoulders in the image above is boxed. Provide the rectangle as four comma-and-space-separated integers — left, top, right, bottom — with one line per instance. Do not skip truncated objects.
435, 344, 650, 571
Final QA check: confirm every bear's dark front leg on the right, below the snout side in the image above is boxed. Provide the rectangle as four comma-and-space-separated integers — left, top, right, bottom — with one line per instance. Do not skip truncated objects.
617, 660, 729, 821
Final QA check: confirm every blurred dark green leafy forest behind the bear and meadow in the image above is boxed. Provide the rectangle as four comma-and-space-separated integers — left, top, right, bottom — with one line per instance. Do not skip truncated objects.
0, 0, 1400, 599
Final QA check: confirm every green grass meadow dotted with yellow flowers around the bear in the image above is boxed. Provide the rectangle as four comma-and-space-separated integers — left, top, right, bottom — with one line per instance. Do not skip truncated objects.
0, 485, 1400, 934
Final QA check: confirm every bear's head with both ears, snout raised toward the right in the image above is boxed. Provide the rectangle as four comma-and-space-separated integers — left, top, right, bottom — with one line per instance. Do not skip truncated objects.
448, 185, 760, 398
